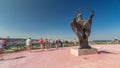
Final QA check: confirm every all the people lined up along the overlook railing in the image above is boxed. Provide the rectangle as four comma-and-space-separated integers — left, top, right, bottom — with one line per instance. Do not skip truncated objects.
0, 38, 65, 54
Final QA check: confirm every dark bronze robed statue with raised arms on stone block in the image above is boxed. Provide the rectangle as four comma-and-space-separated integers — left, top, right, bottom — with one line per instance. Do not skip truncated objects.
71, 9, 94, 49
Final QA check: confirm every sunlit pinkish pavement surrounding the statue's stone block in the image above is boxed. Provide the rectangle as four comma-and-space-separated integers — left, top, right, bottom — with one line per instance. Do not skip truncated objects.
0, 44, 120, 68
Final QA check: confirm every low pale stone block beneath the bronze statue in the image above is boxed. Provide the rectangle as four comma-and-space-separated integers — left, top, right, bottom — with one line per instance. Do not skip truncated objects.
71, 48, 98, 56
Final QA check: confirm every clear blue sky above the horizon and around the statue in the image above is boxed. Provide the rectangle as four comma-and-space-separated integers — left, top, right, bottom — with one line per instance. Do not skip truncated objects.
0, 0, 120, 40
